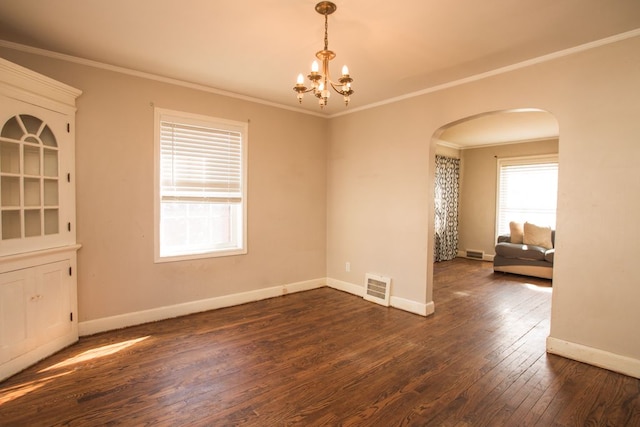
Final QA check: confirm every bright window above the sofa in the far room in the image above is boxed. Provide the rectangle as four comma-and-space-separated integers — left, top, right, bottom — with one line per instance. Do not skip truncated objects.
496, 156, 558, 239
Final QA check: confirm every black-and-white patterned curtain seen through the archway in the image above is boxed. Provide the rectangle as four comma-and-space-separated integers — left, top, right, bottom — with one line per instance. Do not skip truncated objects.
433, 155, 460, 262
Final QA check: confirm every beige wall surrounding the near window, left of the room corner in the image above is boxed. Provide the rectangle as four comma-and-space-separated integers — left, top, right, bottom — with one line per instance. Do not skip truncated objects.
0, 50, 326, 322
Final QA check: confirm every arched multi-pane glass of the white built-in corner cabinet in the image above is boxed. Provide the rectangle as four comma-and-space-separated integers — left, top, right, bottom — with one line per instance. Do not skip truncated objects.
0, 114, 60, 241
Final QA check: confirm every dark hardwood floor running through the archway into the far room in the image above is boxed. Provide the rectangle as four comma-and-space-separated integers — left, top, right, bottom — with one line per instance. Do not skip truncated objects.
0, 259, 640, 426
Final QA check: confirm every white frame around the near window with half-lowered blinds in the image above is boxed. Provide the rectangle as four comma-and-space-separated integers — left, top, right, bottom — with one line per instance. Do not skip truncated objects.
154, 107, 249, 263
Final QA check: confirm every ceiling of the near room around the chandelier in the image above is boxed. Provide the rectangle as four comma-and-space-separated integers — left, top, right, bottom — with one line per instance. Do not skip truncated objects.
0, 0, 640, 145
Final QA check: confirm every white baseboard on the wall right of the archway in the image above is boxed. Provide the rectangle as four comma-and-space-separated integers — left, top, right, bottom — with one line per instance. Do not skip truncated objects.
547, 337, 640, 378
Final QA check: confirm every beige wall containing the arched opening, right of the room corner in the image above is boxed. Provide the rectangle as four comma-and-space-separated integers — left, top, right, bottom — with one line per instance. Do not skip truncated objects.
327, 37, 640, 376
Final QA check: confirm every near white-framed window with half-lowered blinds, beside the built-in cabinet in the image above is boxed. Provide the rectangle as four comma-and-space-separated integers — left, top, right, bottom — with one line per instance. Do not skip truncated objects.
155, 109, 248, 262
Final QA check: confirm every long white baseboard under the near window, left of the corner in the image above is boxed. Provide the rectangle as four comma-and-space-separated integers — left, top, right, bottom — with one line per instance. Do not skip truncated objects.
78, 278, 326, 336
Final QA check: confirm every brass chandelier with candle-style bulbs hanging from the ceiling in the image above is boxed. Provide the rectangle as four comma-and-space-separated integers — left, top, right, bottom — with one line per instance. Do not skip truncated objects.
293, 1, 353, 108
